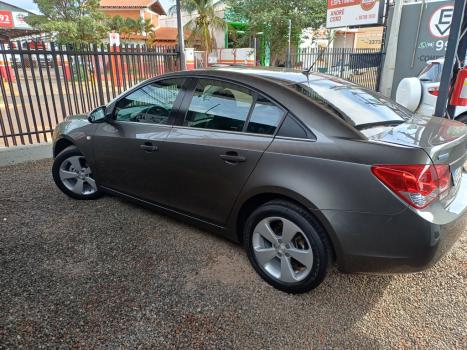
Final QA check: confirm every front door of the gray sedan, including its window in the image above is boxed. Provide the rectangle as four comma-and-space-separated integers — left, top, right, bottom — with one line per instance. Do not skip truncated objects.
94, 79, 183, 202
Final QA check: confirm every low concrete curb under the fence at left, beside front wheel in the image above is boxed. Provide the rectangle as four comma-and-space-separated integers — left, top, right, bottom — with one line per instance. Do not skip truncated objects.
0, 142, 52, 166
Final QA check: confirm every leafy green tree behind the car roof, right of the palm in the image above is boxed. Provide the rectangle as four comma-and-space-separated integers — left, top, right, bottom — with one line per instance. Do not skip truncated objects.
225, 0, 327, 62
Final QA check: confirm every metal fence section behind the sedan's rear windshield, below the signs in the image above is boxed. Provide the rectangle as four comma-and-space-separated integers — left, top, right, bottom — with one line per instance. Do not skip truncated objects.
276, 48, 382, 90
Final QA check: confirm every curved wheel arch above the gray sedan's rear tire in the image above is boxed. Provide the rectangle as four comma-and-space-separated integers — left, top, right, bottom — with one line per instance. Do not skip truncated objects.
233, 188, 341, 259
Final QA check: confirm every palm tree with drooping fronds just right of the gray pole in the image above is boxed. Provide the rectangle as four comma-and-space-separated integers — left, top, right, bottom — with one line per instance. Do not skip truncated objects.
169, 0, 226, 55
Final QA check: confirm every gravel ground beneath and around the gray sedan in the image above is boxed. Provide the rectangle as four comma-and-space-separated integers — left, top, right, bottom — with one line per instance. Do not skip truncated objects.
0, 160, 467, 349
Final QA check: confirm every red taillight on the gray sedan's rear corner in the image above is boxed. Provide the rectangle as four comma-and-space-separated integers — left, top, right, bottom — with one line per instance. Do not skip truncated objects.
371, 164, 451, 209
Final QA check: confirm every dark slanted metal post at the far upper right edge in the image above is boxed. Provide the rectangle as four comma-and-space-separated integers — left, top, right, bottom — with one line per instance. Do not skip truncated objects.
434, 0, 467, 119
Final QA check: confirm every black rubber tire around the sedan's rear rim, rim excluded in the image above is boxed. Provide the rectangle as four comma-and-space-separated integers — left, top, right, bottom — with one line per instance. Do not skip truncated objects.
243, 200, 333, 294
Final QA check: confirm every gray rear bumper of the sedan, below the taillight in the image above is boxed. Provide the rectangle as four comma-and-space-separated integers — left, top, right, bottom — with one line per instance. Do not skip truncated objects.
322, 174, 467, 273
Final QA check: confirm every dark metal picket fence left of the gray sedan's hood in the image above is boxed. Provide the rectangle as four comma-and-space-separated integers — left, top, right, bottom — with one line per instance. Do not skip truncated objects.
0, 42, 179, 147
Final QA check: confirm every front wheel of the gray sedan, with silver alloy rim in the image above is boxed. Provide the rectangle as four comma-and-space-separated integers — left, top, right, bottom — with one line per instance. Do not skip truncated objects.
52, 146, 101, 199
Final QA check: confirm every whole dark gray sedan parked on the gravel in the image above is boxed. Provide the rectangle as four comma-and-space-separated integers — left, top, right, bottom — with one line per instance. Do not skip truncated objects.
52, 68, 467, 293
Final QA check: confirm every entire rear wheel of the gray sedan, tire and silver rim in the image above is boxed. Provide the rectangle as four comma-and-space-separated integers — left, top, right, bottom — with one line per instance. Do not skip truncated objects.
244, 200, 332, 293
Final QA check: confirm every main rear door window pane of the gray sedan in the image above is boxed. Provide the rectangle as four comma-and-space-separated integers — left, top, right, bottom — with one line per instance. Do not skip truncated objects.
183, 79, 253, 131
